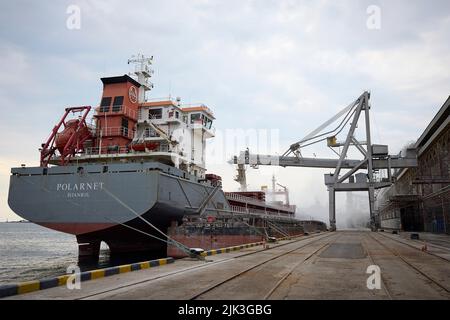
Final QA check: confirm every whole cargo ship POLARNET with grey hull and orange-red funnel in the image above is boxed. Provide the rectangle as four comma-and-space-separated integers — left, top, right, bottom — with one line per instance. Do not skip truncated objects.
8, 55, 326, 259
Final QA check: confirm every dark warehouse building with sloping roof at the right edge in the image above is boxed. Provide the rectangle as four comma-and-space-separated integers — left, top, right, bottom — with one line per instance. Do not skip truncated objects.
376, 97, 450, 234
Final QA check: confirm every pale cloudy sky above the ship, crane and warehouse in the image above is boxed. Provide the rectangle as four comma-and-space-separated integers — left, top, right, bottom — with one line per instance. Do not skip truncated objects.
0, 0, 450, 227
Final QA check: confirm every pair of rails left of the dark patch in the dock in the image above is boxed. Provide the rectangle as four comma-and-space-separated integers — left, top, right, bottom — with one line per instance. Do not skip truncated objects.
189, 234, 339, 300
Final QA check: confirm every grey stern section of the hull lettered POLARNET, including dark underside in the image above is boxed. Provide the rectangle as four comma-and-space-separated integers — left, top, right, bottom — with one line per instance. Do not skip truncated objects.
8, 162, 229, 257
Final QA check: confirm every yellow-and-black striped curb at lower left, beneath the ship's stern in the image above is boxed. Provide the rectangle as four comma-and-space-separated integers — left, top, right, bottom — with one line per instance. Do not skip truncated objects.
0, 257, 175, 298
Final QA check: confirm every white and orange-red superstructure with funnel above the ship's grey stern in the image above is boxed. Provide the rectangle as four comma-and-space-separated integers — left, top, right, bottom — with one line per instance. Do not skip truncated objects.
41, 55, 215, 178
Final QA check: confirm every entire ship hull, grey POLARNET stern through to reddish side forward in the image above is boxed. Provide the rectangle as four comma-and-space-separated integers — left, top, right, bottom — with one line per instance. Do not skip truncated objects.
8, 162, 326, 259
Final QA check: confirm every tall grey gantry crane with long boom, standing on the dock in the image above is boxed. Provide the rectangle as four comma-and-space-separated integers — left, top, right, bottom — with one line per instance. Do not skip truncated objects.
236, 91, 417, 231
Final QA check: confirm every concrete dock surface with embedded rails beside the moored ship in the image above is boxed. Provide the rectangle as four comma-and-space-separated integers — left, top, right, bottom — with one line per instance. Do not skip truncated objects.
3, 231, 450, 300
